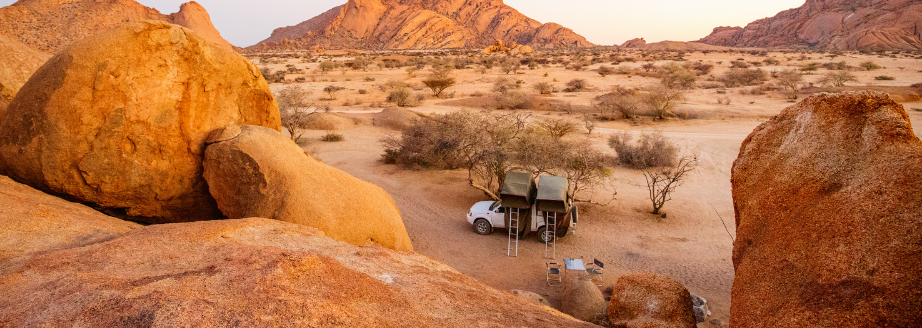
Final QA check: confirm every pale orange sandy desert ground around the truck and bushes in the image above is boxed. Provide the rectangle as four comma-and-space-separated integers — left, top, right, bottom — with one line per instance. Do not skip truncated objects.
256, 53, 922, 327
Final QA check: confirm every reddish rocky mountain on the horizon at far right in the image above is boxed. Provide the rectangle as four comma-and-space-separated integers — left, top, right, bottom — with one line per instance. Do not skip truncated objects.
698, 0, 922, 51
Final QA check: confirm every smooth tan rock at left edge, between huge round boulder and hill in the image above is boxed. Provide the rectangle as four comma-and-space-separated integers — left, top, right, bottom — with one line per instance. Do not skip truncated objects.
0, 35, 50, 116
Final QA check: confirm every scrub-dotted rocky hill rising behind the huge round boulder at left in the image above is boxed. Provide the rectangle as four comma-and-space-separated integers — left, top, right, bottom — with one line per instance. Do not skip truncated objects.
0, 0, 232, 53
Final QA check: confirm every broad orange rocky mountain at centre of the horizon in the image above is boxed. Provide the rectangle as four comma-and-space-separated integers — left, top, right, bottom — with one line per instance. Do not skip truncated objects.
247, 0, 593, 51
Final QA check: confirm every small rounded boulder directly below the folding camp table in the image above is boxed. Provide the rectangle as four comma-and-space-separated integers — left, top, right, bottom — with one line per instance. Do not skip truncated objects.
560, 277, 605, 323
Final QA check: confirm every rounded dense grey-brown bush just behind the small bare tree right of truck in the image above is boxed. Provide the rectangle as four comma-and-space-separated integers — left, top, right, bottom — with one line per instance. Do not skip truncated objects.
608, 131, 679, 169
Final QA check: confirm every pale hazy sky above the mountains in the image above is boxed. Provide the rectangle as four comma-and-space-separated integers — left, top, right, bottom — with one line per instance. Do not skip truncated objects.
0, 0, 804, 47
